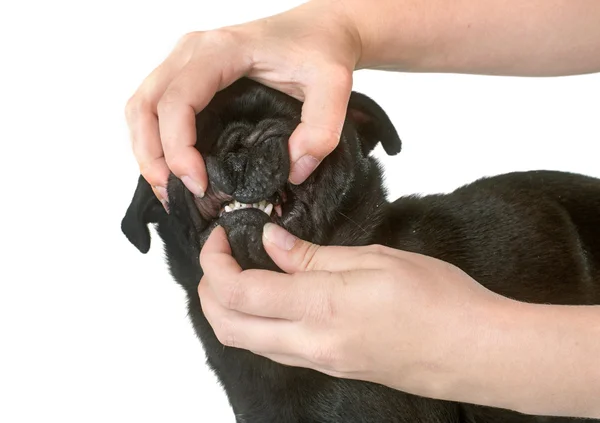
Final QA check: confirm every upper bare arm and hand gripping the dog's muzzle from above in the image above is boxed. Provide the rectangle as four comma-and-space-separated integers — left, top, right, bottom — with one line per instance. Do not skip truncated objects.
126, 0, 600, 207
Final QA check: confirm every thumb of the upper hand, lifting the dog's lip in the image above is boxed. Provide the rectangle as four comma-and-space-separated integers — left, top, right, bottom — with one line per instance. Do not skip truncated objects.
289, 73, 352, 185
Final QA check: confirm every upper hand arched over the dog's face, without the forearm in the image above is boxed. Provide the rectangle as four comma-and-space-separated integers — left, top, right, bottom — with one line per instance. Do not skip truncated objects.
126, 0, 360, 206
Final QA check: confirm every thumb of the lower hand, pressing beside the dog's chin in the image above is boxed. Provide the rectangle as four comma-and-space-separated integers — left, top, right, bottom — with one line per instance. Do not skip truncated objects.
263, 223, 360, 273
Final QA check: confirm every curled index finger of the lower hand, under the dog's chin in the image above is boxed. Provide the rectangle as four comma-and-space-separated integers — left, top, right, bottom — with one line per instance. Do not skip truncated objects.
200, 227, 328, 320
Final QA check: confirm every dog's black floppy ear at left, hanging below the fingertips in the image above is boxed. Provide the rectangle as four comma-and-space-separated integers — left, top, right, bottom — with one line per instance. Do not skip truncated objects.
121, 175, 167, 254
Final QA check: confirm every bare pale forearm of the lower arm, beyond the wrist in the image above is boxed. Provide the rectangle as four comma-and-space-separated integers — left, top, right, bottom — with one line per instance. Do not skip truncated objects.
442, 300, 600, 418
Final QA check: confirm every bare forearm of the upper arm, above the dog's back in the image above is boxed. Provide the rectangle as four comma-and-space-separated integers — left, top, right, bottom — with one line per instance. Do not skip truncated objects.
341, 0, 600, 76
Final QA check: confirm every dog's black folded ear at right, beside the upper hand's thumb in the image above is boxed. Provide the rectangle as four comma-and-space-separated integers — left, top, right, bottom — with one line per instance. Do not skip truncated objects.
347, 91, 402, 156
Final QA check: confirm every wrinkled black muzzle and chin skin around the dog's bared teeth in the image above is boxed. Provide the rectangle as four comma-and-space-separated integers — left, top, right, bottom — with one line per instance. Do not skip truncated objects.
168, 119, 300, 270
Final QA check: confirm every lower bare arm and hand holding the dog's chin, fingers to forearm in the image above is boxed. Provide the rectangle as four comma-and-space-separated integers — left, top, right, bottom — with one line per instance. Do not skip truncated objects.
199, 226, 600, 418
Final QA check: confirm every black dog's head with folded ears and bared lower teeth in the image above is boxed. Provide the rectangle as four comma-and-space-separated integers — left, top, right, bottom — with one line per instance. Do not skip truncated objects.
121, 79, 401, 270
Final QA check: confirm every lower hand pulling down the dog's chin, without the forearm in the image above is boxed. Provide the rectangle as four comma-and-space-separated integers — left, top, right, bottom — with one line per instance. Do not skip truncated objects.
198, 224, 502, 399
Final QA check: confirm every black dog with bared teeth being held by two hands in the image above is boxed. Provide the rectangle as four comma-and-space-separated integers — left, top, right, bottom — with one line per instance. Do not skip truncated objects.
122, 79, 600, 423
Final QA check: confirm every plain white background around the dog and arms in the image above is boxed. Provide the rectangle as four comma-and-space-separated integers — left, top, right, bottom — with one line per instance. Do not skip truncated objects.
0, 0, 600, 423
